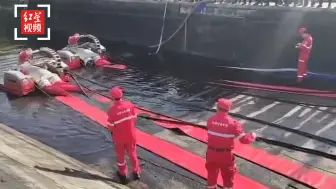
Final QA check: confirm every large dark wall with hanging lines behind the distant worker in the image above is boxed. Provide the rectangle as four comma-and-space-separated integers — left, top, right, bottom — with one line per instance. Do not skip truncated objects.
5, 0, 336, 74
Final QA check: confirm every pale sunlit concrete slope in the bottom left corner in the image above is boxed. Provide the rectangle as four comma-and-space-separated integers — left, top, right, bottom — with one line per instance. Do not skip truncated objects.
0, 123, 129, 189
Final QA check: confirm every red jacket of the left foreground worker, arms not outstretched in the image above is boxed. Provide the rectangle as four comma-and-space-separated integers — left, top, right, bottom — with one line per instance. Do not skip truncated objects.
107, 101, 136, 143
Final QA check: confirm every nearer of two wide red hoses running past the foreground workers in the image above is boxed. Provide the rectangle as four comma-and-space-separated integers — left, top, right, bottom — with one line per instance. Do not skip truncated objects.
56, 96, 268, 189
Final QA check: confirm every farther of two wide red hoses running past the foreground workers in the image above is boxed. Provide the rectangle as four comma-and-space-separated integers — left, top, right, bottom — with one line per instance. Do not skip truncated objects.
88, 91, 336, 189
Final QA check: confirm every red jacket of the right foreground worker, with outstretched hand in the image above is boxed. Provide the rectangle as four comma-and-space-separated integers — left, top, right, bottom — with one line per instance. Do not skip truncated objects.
207, 112, 255, 150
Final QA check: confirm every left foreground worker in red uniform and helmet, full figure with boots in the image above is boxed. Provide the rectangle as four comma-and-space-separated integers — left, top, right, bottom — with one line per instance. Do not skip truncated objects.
107, 87, 140, 183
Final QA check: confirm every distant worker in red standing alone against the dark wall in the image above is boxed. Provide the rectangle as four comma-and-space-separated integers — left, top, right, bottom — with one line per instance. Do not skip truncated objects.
295, 28, 313, 82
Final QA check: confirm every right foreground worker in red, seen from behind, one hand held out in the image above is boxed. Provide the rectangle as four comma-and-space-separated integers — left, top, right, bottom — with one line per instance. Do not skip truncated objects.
205, 98, 256, 189
